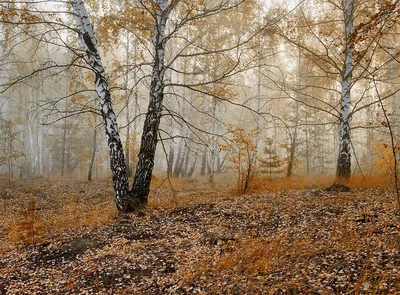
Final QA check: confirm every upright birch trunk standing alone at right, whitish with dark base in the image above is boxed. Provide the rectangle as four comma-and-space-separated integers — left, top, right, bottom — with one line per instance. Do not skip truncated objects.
336, 0, 354, 179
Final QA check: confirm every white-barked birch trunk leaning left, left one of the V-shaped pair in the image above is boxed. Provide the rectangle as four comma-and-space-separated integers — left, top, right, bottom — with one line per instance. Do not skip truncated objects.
72, 0, 131, 212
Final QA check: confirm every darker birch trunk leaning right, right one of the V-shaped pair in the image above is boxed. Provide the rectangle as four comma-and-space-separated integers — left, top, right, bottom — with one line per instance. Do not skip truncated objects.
130, 0, 171, 210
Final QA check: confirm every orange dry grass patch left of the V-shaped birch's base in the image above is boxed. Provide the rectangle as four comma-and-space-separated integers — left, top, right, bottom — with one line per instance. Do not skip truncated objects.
0, 179, 117, 251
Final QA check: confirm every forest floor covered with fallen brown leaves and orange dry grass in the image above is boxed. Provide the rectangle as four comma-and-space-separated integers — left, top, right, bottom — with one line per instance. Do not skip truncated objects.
0, 179, 400, 295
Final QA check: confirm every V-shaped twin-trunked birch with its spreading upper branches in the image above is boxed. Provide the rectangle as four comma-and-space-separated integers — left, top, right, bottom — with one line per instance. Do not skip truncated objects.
0, 0, 272, 212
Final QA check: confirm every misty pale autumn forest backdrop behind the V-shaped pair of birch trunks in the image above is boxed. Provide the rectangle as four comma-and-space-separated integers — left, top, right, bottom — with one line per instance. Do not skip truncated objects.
0, 1, 398, 197
